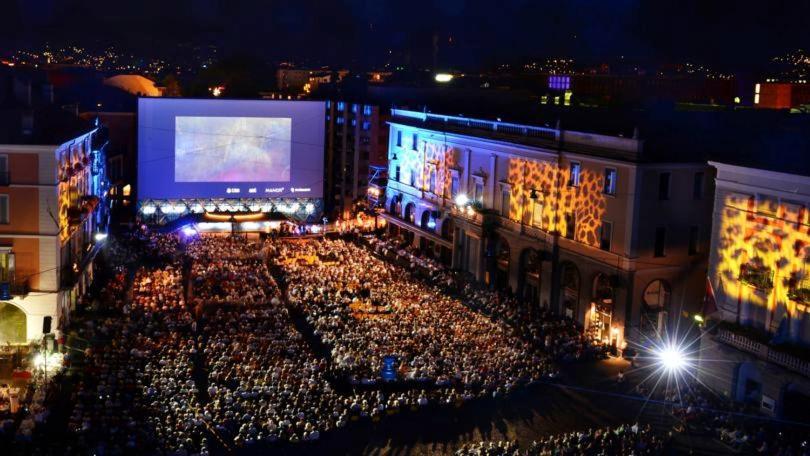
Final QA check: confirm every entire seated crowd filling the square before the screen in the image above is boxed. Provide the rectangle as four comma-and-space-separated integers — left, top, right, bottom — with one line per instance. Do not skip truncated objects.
42, 232, 800, 455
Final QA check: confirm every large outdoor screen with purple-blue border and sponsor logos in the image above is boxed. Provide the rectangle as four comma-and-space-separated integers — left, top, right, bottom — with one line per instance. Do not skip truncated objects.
138, 98, 325, 199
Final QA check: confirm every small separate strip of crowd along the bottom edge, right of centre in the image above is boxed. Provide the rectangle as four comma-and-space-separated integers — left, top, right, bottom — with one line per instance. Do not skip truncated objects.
456, 424, 669, 456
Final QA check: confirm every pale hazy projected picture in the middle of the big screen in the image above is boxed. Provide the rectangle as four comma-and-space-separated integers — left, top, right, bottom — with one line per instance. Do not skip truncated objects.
174, 116, 292, 182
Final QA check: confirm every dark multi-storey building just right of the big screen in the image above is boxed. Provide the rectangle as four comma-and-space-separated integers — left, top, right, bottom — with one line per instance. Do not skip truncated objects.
324, 101, 388, 219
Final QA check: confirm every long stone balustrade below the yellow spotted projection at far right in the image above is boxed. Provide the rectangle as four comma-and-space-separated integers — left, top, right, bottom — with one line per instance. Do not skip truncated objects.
715, 324, 810, 377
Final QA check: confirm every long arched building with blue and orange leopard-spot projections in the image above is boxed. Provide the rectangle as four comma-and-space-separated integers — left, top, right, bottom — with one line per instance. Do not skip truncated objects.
385, 110, 712, 346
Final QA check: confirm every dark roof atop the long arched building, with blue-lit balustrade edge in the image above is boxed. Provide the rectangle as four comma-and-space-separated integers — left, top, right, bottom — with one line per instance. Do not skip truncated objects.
391, 109, 810, 176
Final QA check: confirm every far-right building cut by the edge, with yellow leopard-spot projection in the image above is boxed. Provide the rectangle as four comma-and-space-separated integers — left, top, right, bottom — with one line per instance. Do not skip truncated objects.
699, 162, 810, 420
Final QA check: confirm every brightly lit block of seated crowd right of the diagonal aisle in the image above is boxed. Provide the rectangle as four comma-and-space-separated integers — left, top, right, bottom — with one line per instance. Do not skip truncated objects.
278, 240, 555, 394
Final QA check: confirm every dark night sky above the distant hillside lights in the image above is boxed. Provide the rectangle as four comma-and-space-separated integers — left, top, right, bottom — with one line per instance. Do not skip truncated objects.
0, 0, 810, 67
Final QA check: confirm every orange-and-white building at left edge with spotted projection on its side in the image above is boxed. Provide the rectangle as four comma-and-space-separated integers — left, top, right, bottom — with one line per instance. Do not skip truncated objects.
0, 130, 107, 344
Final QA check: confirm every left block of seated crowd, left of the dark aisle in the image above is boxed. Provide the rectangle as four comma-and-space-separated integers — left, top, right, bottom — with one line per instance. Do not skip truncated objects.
69, 265, 202, 453
